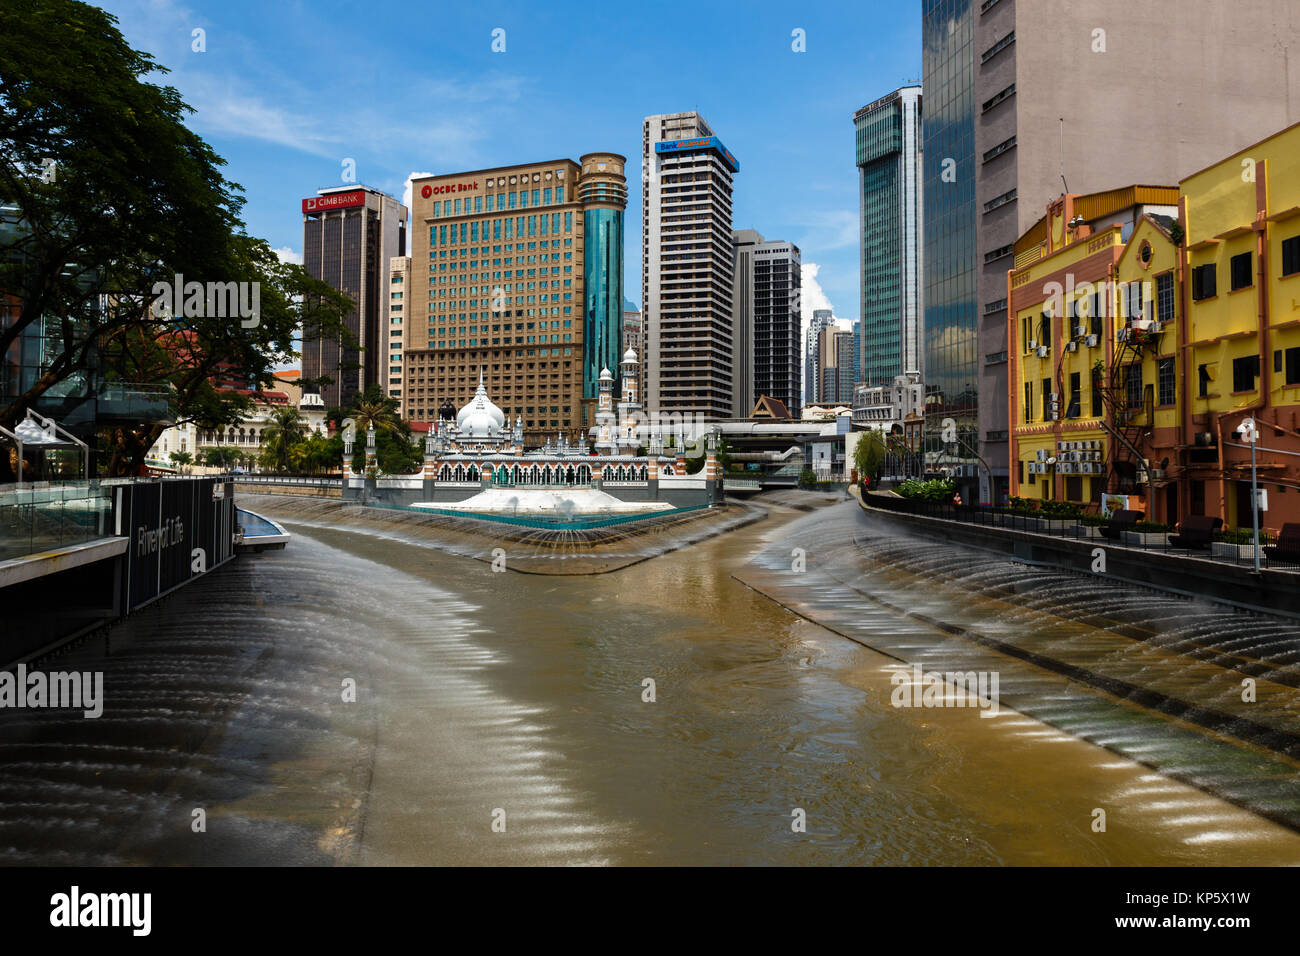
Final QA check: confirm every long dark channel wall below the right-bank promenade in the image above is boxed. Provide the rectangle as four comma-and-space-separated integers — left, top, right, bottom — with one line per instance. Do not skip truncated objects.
859, 499, 1300, 618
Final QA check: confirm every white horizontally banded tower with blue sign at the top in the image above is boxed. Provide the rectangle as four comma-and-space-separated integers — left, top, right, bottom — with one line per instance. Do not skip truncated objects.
641, 112, 749, 418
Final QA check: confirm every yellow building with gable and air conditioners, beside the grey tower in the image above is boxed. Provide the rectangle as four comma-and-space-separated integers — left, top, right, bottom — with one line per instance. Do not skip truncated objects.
1008, 186, 1178, 514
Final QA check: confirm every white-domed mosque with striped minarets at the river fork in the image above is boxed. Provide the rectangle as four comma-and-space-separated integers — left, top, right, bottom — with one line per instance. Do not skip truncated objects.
347, 349, 723, 515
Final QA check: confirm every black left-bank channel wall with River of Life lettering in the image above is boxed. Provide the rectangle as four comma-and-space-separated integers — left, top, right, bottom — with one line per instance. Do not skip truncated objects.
0, 477, 235, 667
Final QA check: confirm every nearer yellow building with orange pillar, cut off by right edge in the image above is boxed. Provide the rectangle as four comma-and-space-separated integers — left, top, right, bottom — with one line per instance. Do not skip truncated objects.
1174, 125, 1300, 531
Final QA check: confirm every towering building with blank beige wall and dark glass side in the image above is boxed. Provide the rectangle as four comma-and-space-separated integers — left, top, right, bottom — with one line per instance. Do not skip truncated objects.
922, 0, 1300, 501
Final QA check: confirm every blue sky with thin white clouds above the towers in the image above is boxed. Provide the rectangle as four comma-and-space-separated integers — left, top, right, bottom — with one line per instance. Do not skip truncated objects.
104, 0, 920, 332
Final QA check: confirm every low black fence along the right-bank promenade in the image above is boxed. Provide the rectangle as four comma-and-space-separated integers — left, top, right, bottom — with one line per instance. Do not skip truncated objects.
863, 493, 1300, 571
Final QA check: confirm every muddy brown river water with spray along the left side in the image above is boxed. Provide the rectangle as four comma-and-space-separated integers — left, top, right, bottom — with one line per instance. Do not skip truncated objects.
0, 499, 1300, 865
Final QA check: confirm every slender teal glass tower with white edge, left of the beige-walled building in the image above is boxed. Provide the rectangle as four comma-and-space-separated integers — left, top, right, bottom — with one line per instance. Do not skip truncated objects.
853, 86, 922, 385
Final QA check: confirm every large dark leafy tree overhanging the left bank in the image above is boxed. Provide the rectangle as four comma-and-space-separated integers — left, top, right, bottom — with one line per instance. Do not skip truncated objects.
0, 0, 355, 473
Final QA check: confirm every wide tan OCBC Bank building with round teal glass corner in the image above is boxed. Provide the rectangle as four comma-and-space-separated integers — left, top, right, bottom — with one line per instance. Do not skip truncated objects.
404, 152, 627, 445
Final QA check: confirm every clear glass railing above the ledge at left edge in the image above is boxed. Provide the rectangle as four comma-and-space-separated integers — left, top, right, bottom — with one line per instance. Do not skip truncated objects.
0, 481, 113, 561
